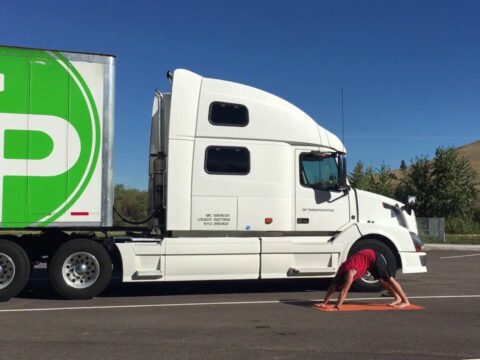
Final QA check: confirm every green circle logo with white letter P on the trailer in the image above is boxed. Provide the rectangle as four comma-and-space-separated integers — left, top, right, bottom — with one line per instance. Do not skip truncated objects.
0, 47, 100, 228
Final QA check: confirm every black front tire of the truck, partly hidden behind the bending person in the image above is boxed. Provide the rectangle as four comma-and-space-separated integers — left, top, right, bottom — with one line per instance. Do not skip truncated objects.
349, 239, 398, 292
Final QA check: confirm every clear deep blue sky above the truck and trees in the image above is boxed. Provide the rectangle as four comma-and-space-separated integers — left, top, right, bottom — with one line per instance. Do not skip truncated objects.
0, 0, 480, 189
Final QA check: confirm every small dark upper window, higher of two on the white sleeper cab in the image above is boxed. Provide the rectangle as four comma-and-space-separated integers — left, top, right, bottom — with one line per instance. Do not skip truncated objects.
208, 101, 248, 127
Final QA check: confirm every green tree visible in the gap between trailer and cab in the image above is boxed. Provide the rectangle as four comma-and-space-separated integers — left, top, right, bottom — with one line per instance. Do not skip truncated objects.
114, 184, 148, 226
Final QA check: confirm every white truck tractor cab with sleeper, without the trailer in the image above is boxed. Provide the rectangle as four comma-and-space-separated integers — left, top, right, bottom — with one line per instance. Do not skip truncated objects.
117, 70, 426, 290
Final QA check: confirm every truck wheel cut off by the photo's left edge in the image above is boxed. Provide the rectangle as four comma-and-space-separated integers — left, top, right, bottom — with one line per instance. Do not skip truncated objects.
0, 240, 30, 301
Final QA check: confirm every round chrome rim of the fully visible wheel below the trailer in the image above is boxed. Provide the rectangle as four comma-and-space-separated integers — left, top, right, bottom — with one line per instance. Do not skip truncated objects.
62, 252, 100, 289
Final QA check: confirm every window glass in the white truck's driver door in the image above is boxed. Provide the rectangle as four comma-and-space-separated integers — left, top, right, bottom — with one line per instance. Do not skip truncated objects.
300, 153, 338, 190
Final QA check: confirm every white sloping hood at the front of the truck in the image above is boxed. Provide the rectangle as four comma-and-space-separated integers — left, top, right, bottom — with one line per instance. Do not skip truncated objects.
356, 190, 418, 234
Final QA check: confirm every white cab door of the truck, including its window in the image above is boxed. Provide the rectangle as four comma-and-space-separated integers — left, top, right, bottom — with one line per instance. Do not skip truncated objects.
295, 149, 350, 233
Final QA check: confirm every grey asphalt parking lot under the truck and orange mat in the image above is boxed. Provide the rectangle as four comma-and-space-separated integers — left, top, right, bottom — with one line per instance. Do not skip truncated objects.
0, 250, 480, 359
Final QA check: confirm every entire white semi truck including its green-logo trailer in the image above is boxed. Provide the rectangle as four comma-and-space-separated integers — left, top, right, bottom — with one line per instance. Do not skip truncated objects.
0, 46, 427, 300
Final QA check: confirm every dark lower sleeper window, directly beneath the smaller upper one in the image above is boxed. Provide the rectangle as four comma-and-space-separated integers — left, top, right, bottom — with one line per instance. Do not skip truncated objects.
205, 146, 250, 175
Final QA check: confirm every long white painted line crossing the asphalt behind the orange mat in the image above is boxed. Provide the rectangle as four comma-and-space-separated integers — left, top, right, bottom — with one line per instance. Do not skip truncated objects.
0, 295, 480, 313
